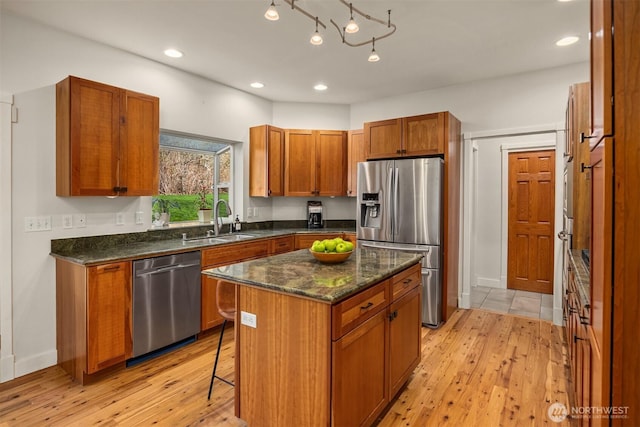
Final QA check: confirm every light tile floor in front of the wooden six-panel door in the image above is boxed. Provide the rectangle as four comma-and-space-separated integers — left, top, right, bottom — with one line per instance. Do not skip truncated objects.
471, 286, 553, 321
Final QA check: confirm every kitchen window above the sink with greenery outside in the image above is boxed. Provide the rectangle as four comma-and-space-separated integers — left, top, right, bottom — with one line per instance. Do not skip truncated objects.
152, 131, 233, 226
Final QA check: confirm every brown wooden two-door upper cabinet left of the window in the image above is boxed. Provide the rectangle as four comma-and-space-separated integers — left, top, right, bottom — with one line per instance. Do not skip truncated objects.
56, 76, 160, 196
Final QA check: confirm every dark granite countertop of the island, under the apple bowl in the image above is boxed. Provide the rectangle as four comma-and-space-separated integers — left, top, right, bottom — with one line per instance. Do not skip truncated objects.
203, 248, 422, 304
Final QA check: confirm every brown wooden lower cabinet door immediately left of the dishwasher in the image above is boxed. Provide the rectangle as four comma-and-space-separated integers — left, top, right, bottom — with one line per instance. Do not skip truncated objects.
87, 262, 133, 374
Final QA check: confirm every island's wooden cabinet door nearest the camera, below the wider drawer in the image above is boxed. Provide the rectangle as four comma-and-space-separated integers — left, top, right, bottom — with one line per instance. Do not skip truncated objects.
331, 310, 389, 426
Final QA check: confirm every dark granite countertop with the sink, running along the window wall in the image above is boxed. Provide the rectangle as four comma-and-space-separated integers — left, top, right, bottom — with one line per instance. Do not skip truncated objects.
51, 228, 354, 265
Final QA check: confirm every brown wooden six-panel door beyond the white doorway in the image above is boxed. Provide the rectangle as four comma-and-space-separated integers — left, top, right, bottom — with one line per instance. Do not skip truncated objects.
507, 150, 555, 294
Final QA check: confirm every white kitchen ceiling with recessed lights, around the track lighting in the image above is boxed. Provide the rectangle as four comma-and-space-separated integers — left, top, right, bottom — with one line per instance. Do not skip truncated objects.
0, 0, 589, 104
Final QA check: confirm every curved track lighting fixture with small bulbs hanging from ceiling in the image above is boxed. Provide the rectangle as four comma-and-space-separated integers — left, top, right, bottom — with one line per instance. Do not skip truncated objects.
264, 0, 396, 62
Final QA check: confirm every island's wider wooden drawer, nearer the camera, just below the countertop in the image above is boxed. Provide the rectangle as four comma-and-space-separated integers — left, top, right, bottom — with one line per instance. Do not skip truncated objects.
331, 280, 390, 340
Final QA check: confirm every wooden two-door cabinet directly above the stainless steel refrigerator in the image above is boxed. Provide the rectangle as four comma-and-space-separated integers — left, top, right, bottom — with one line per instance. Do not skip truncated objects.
364, 112, 448, 159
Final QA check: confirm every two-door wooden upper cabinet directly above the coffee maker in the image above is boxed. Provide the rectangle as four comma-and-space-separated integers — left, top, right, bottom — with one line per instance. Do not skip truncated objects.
284, 129, 347, 197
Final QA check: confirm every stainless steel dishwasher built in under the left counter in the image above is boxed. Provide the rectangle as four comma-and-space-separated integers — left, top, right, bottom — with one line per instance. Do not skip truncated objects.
133, 251, 200, 357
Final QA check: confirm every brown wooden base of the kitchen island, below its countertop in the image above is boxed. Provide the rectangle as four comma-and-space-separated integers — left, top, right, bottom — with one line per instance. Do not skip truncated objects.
235, 264, 421, 426
